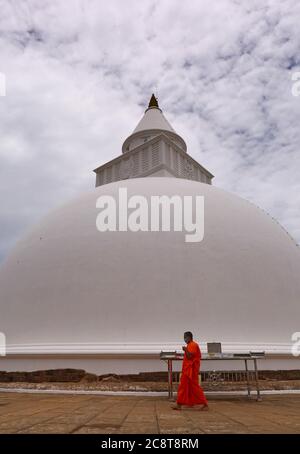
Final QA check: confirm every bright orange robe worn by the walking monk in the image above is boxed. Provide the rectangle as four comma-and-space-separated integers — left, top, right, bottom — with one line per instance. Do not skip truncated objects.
177, 341, 207, 406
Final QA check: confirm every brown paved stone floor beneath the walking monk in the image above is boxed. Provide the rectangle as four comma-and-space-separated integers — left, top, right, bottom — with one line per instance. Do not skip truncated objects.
0, 393, 300, 434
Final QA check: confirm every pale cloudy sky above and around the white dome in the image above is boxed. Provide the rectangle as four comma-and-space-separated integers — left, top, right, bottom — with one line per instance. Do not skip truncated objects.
0, 0, 300, 261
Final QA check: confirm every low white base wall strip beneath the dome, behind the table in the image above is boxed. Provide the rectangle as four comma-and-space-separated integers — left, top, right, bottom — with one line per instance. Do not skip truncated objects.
0, 357, 300, 375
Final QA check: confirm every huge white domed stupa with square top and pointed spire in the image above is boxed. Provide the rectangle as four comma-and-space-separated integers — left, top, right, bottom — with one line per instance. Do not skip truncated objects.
0, 96, 300, 373
